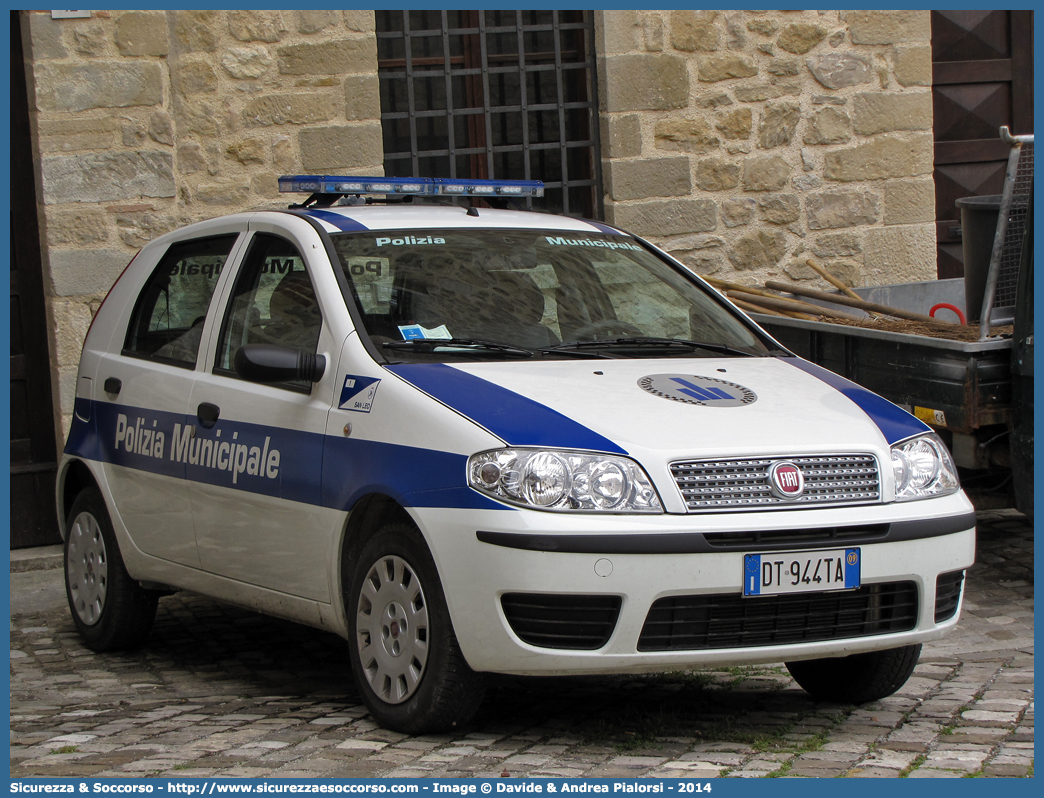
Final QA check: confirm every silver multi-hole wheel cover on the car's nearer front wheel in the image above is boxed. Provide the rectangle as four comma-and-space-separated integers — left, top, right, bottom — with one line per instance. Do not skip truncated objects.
356, 555, 429, 704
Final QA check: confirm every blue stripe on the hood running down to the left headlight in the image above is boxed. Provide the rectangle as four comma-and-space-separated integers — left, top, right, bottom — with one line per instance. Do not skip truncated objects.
385, 363, 626, 454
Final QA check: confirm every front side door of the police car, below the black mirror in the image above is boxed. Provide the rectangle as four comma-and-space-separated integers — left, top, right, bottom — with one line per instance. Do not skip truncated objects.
187, 215, 347, 602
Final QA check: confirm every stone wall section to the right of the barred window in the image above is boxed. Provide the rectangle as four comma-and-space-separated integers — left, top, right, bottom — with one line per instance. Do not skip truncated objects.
596, 10, 935, 287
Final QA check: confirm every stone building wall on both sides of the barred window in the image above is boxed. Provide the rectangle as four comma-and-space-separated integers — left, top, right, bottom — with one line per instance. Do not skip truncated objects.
21, 10, 935, 444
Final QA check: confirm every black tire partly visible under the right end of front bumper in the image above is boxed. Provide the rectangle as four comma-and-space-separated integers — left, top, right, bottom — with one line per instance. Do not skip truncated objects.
786, 644, 921, 704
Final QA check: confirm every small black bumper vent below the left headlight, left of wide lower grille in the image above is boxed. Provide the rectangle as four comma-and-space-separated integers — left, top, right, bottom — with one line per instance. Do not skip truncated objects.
500, 593, 621, 651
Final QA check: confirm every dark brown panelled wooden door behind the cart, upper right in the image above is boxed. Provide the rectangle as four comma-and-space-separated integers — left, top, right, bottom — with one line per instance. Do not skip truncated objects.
931, 10, 1034, 278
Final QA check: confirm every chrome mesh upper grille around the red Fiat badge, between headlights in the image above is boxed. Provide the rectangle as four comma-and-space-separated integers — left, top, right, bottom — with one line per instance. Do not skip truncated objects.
670, 454, 881, 513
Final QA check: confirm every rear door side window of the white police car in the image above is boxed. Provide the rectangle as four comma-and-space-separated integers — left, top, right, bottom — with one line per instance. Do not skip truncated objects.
123, 233, 238, 369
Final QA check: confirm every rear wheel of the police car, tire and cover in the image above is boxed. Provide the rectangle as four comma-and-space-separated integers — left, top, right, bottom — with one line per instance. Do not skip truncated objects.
65, 488, 159, 652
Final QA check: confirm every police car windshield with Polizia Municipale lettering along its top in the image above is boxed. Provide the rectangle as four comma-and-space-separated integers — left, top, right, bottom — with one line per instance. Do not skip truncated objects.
333, 228, 767, 361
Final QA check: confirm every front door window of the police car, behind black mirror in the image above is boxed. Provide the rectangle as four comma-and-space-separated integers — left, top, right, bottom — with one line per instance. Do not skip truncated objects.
214, 234, 323, 388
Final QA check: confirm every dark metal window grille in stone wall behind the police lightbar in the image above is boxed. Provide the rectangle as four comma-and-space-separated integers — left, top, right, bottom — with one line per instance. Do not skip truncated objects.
377, 9, 602, 218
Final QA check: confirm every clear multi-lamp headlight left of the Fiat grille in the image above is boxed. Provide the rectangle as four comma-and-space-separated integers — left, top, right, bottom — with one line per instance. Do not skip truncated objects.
468, 449, 663, 513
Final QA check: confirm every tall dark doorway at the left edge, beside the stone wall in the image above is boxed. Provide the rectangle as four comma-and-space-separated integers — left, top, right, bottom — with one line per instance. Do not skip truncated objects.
10, 11, 61, 548
